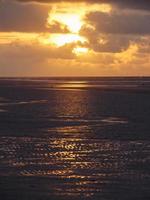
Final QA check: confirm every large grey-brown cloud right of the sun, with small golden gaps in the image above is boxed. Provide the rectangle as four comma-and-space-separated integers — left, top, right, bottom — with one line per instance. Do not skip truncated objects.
80, 10, 150, 53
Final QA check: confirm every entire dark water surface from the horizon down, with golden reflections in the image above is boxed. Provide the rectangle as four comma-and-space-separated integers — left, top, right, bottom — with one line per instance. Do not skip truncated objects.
0, 78, 150, 200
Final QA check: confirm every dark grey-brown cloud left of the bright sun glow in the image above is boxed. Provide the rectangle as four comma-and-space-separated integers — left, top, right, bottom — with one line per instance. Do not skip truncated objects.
0, 1, 50, 32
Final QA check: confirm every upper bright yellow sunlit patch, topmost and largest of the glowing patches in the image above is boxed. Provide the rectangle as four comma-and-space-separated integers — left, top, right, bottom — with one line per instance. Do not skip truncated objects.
47, 3, 111, 33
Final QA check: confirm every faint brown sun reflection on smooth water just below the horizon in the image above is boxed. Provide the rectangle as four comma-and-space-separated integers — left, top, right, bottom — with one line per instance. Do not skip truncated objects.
50, 86, 90, 119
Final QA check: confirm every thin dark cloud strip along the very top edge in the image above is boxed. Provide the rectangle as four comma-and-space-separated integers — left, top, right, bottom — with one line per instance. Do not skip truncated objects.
18, 0, 150, 11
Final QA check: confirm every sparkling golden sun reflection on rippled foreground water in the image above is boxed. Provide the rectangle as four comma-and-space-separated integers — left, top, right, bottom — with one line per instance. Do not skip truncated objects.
0, 135, 149, 198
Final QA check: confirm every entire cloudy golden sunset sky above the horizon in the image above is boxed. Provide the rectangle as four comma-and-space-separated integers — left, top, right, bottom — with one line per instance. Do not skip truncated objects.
0, 0, 150, 77
